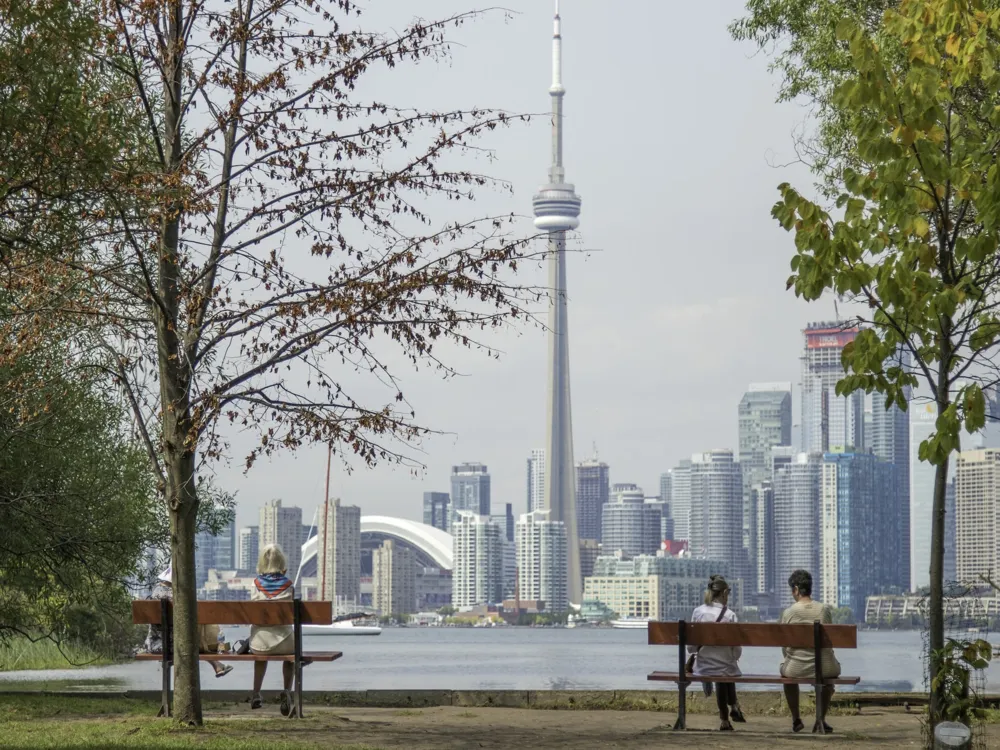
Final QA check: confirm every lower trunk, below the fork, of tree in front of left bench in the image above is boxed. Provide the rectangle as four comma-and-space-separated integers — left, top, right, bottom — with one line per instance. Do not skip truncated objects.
165, 453, 202, 725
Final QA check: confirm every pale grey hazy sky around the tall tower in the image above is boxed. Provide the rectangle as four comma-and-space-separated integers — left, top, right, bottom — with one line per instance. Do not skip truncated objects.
219, 0, 833, 525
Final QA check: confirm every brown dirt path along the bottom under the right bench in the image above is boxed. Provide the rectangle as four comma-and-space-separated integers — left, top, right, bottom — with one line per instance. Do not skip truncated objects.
227, 707, 1000, 750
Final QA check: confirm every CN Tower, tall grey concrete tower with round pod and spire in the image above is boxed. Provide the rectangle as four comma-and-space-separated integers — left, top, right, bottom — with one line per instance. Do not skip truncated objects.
534, 0, 583, 604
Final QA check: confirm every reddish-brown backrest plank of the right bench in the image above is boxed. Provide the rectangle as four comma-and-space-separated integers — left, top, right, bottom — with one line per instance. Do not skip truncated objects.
649, 622, 858, 648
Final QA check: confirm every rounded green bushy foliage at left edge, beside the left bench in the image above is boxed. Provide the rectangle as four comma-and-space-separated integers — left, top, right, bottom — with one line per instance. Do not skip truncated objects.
0, 355, 157, 650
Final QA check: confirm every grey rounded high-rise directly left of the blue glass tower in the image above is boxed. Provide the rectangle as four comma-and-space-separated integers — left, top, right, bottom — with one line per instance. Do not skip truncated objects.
774, 453, 823, 608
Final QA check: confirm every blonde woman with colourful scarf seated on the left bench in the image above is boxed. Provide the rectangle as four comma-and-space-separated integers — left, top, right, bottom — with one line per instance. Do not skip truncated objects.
250, 544, 295, 716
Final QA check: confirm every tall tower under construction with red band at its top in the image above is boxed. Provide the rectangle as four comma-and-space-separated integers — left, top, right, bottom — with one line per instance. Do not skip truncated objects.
801, 323, 865, 453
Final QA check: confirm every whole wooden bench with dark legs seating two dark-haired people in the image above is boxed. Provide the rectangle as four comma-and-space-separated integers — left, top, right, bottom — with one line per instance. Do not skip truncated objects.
646, 620, 861, 734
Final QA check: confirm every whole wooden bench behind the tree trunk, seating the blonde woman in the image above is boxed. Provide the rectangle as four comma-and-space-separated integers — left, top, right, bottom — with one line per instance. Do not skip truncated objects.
132, 599, 343, 718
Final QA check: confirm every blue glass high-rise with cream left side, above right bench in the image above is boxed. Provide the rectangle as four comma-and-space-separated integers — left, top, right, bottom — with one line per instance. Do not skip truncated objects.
820, 452, 901, 617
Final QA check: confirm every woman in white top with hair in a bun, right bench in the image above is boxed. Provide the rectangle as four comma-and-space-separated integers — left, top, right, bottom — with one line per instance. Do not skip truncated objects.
688, 576, 746, 732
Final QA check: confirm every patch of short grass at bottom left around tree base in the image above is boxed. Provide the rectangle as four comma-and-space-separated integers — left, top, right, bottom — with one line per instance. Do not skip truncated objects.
0, 694, 375, 750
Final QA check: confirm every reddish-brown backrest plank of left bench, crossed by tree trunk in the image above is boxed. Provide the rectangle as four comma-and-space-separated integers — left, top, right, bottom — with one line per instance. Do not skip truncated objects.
132, 599, 333, 625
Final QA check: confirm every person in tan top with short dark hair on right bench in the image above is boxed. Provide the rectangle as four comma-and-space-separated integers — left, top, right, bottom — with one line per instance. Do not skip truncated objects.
779, 570, 840, 734
